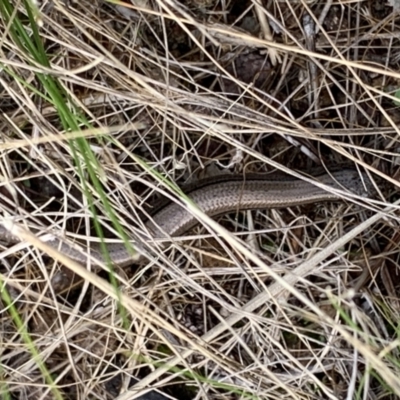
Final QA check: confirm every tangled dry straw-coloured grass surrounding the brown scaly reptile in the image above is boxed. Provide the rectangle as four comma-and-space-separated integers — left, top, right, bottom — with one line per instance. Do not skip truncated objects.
0, 0, 400, 400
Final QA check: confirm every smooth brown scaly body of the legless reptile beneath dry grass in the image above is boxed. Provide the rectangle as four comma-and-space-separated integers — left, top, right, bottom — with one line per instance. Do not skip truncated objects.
0, 169, 373, 266
